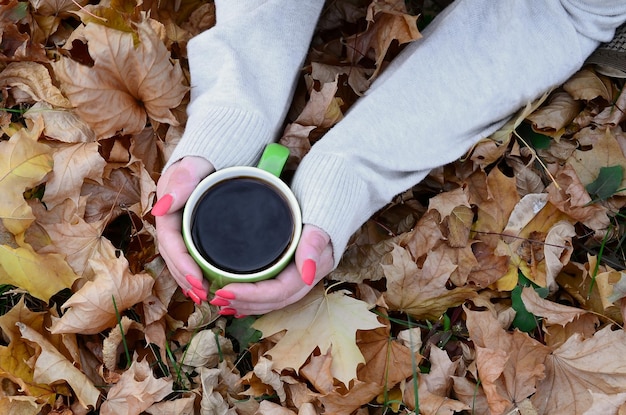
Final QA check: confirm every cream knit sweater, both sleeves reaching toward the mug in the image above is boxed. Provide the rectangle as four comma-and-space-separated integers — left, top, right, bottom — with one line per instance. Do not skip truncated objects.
166, 0, 626, 265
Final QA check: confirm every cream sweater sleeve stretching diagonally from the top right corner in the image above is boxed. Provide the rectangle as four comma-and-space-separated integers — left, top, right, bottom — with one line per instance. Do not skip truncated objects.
292, 0, 626, 265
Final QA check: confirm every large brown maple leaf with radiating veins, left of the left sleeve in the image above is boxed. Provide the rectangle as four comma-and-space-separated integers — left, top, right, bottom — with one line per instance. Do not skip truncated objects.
54, 22, 187, 138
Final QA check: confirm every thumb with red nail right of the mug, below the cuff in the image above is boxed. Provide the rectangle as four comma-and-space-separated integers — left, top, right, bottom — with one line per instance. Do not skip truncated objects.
295, 224, 334, 285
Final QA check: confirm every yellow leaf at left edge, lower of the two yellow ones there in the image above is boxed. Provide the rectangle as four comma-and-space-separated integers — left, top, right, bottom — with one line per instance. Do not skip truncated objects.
0, 234, 78, 301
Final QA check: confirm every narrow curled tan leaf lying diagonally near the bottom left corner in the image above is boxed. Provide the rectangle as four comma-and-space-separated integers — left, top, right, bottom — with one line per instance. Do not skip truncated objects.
16, 323, 100, 408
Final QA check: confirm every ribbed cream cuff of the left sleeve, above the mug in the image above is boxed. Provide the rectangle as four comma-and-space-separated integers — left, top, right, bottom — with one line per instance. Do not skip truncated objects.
163, 107, 272, 171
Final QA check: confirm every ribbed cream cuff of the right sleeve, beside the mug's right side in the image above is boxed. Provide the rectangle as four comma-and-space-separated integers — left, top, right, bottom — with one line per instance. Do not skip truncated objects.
291, 152, 377, 267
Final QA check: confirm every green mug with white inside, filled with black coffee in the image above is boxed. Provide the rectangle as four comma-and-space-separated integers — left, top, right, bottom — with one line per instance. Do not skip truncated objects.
182, 143, 302, 292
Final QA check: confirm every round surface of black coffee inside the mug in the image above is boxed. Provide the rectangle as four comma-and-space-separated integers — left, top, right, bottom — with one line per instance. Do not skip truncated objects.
191, 177, 294, 274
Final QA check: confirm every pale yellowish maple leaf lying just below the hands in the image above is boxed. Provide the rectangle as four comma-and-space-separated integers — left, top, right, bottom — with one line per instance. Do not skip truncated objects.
253, 286, 382, 385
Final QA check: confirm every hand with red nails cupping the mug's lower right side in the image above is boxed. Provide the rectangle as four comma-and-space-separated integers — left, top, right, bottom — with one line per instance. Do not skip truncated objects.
210, 225, 334, 317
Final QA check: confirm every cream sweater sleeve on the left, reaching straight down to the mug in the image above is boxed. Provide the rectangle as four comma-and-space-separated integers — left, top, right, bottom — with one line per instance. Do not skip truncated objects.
164, 0, 324, 170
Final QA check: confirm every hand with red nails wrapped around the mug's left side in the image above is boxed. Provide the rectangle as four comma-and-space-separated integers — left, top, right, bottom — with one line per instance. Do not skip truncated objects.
152, 157, 215, 304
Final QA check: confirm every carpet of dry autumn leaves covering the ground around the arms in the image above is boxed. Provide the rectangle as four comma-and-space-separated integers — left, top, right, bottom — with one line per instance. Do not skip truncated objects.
0, 0, 626, 415
